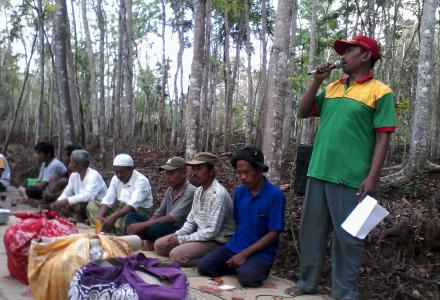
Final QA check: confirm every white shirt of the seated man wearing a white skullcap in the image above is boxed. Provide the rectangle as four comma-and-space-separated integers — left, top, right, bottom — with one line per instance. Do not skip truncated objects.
101, 170, 153, 209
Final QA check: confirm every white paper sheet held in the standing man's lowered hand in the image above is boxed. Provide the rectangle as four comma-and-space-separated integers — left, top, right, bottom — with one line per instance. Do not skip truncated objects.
341, 196, 389, 239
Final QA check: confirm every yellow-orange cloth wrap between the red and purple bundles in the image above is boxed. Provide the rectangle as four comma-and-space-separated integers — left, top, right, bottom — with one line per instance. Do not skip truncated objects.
28, 234, 133, 300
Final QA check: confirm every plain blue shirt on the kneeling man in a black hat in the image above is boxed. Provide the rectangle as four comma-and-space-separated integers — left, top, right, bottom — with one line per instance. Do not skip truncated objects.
225, 179, 286, 263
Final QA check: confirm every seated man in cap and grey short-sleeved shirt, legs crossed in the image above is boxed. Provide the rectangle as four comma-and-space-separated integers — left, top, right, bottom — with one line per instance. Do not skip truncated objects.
125, 156, 196, 251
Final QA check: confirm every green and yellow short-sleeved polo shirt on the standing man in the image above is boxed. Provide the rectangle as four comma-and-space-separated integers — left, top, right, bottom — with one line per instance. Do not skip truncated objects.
307, 75, 396, 188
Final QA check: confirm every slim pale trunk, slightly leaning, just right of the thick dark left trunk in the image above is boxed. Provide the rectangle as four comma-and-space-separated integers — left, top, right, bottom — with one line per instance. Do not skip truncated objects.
81, 0, 99, 149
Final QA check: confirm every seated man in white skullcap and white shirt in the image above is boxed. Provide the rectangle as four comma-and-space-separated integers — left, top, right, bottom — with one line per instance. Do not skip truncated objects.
87, 154, 153, 234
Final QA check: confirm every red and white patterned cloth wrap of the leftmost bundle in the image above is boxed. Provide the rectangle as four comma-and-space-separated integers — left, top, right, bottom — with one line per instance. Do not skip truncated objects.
3, 210, 78, 284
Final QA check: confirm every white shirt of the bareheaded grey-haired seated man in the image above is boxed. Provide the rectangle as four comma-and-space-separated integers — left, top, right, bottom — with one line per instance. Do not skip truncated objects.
58, 168, 107, 205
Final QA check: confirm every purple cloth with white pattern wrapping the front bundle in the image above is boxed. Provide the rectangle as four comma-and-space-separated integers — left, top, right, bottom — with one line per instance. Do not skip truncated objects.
69, 253, 188, 300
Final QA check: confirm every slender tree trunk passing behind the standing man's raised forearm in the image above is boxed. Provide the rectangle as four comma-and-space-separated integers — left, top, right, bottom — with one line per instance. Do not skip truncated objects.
300, 0, 318, 144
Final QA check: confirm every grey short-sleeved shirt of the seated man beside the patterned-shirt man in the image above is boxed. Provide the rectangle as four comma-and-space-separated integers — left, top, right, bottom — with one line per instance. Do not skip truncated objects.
154, 181, 196, 227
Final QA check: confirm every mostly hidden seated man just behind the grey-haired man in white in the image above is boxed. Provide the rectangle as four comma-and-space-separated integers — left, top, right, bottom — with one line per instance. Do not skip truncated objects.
43, 145, 81, 203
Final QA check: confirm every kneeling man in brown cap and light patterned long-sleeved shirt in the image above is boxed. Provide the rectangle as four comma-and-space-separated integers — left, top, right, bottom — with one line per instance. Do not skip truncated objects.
154, 152, 234, 267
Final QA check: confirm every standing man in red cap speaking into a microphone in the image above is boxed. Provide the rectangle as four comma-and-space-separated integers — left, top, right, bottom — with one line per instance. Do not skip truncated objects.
286, 35, 396, 300
